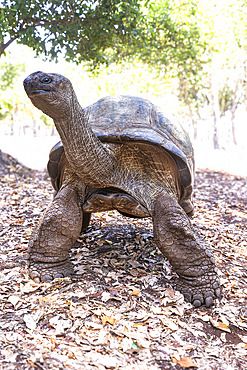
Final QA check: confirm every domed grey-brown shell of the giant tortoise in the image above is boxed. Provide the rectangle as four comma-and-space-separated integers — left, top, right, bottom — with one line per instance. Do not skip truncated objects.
48, 96, 194, 201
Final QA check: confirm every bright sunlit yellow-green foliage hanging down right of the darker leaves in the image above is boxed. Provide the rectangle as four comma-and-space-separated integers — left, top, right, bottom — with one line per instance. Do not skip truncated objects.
113, 0, 210, 118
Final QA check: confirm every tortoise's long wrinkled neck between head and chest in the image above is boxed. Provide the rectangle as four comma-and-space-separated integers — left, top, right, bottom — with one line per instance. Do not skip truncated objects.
54, 94, 115, 187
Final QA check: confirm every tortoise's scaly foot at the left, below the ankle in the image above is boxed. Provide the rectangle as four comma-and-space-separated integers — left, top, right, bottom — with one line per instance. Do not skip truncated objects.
29, 260, 74, 283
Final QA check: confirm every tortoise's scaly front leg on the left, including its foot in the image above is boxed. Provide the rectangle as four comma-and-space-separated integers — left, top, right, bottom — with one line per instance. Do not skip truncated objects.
28, 184, 83, 282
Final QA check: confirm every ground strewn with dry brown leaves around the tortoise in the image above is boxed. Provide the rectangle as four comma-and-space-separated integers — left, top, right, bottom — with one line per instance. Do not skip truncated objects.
0, 152, 247, 370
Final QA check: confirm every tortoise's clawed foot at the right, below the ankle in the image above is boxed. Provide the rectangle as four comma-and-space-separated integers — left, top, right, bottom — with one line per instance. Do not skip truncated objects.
175, 274, 221, 308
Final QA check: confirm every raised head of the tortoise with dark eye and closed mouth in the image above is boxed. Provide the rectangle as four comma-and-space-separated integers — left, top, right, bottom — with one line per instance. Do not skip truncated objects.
23, 71, 75, 119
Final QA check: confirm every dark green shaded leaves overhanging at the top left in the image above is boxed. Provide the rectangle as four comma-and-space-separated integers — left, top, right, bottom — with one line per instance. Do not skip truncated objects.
0, 0, 143, 65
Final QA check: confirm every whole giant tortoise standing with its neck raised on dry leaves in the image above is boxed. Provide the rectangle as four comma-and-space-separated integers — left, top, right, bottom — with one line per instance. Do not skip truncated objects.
24, 72, 220, 307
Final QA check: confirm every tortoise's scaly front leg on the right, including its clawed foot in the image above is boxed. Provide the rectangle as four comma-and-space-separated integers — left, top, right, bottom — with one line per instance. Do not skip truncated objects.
153, 195, 220, 307
